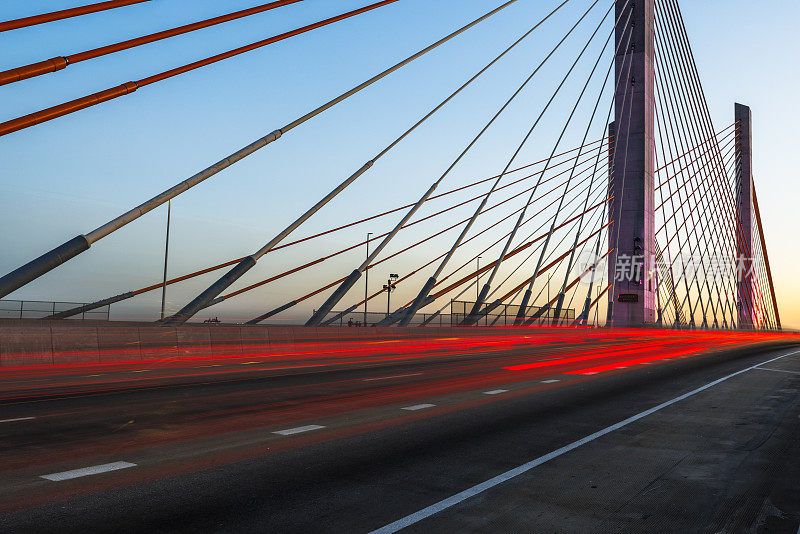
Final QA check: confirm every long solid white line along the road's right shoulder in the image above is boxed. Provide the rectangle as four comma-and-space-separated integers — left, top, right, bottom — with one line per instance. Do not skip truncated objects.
370, 350, 800, 534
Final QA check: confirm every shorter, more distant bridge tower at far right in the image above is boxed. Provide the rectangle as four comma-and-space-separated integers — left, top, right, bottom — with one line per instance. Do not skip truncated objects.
735, 104, 755, 328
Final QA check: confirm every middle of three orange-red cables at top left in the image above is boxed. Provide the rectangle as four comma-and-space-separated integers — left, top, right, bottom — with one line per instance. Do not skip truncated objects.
0, 0, 303, 85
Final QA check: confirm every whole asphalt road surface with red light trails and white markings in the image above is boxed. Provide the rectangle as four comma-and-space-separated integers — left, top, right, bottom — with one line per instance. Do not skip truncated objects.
0, 331, 800, 533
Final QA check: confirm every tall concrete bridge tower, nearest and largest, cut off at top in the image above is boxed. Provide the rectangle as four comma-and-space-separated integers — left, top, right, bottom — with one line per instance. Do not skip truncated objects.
608, 0, 656, 326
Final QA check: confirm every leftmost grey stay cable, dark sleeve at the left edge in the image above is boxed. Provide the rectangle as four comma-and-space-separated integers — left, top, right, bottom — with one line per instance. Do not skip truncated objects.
0, 0, 517, 298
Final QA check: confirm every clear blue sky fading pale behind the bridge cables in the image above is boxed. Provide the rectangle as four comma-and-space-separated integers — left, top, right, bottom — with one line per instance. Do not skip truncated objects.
0, 0, 800, 326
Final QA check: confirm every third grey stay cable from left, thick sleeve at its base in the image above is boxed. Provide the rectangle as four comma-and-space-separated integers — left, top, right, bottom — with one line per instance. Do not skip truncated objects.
306, 0, 599, 326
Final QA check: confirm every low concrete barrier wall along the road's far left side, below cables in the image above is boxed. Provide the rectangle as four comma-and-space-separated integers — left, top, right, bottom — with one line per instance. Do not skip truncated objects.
0, 319, 524, 367
